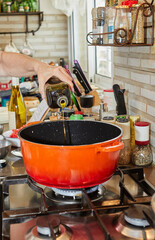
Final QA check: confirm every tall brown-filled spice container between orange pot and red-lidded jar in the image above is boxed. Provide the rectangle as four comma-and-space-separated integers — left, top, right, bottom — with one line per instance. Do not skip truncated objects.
116, 118, 131, 165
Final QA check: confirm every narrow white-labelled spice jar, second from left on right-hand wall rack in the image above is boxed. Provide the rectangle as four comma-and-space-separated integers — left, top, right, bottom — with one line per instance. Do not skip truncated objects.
97, 7, 106, 45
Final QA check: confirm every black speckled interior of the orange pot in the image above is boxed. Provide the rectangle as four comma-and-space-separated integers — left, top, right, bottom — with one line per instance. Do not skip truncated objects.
19, 120, 122, 146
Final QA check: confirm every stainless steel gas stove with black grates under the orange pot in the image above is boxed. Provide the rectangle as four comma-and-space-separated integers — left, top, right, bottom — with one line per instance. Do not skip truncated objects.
0, 160, 155, 240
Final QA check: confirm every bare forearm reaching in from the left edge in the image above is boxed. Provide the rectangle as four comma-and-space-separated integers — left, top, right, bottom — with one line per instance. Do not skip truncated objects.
0, 52, 40, 77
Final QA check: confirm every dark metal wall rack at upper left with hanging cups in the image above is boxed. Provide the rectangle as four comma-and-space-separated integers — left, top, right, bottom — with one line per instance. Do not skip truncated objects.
0, 12, 43, 35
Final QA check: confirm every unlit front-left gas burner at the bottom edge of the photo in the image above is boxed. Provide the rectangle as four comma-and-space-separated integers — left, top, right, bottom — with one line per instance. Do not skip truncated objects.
25, 216, 72, 240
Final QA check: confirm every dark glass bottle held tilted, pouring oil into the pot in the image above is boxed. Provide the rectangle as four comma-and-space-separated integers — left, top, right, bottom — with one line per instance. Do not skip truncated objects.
45, 77, 71, 108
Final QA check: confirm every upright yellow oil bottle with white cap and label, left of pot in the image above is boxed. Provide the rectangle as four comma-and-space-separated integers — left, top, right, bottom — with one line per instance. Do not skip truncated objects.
8, 77, 26, 129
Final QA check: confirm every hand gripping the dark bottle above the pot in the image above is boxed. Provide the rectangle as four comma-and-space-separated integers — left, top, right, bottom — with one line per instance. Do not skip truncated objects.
37, 63, 74, 98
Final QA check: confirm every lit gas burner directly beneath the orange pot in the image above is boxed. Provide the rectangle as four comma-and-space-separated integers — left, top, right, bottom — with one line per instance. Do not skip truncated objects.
44, 185, 106, 204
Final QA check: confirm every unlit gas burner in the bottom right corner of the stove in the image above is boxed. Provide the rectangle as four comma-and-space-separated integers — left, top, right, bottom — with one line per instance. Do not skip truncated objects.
114, 204, 155, 240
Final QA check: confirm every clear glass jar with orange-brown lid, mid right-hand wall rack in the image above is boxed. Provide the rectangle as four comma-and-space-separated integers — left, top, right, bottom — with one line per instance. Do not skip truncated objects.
114, 5, 129, 43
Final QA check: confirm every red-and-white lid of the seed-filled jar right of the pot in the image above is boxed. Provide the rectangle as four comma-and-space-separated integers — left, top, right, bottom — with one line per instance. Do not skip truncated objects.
135, 122, 150, 145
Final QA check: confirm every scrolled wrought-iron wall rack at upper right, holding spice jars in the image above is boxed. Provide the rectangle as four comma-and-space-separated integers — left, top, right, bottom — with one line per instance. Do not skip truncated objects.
86, 0, 154, 47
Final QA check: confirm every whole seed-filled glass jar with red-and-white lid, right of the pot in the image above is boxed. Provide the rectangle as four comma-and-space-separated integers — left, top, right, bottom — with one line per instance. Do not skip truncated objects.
132, 122, 153, 167
